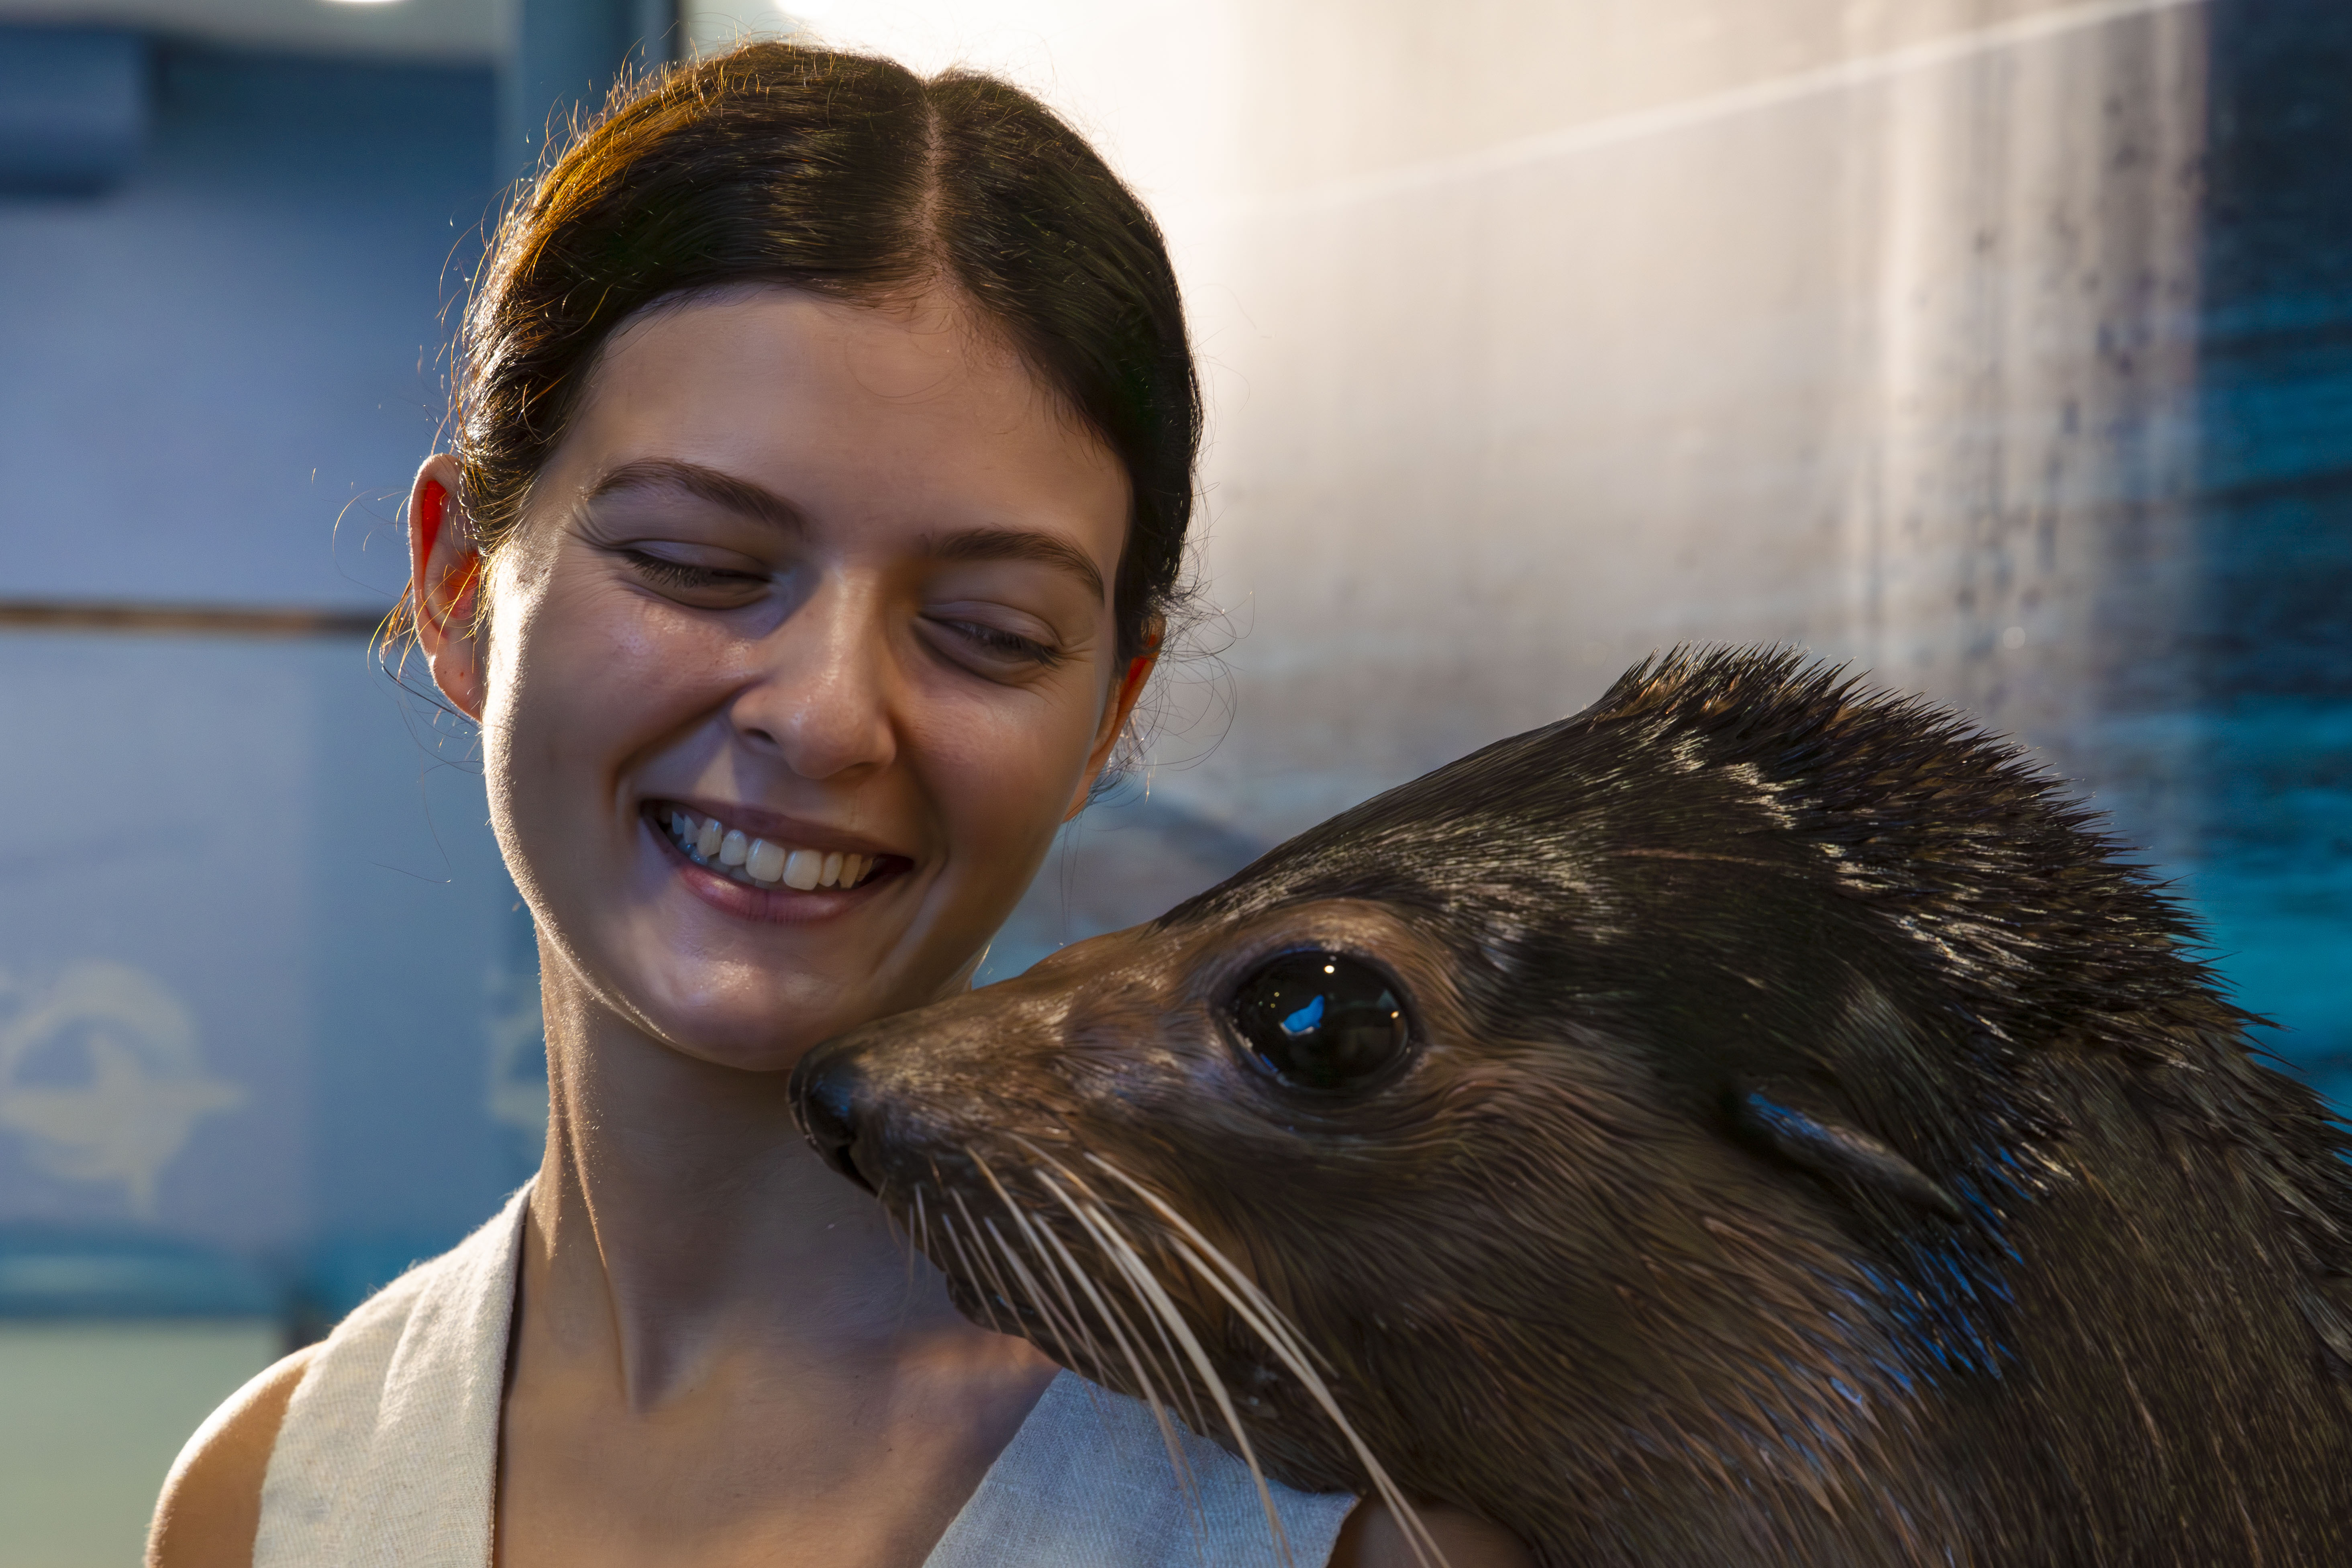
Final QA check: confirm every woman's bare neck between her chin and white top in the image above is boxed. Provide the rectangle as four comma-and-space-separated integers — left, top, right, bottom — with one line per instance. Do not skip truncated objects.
524, 969, 997, 1411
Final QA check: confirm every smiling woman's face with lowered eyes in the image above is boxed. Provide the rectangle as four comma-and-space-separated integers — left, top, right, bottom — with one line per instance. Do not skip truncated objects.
419, 287, 1138, 1070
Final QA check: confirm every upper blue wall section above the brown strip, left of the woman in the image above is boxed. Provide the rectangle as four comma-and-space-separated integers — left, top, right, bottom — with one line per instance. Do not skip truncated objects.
0, 47, 496, 606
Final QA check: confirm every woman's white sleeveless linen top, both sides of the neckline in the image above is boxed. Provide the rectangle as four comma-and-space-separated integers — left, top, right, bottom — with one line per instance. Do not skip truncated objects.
254, 1187, 1355, 1568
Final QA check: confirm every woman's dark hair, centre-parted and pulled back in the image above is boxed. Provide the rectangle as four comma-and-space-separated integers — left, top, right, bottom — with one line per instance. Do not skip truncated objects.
454, 42, 1202, 658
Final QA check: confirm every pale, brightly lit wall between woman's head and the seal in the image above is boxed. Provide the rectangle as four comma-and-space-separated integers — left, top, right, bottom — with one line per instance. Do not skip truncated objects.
699, 0, 2204, 945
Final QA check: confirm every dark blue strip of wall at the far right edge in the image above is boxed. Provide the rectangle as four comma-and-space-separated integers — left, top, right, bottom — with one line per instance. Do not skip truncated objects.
2183, 0, 2352, 1105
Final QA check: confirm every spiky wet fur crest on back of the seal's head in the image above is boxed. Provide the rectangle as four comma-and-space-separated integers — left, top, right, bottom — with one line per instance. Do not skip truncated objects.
1571, 649, 2244, 1056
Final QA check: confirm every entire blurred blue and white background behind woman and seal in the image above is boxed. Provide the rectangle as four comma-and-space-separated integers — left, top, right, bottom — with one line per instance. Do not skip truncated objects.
0, 0, 2352, 1568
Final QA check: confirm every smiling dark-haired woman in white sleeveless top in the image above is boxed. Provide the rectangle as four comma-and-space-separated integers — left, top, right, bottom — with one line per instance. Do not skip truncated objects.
151, 34, 1543, 1568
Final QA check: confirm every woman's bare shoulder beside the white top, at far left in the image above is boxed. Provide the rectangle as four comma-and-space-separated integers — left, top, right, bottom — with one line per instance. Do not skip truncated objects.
146, 1345, 320, 1568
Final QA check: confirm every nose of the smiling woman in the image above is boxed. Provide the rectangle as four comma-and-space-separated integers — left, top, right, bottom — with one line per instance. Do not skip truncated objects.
732, 583, 896, 778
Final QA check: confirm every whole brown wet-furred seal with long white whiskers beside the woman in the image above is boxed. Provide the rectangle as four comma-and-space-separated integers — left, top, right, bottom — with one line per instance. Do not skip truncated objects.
798, 651, 2352, 1568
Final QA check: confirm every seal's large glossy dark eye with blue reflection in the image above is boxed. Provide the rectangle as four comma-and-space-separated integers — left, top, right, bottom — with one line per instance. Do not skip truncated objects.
1232, 952, 1409, 1089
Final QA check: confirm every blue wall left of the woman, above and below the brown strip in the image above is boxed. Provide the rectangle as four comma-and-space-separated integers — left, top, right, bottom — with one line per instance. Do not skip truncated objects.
0, 47, 524, 1317
